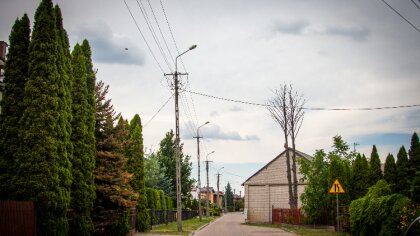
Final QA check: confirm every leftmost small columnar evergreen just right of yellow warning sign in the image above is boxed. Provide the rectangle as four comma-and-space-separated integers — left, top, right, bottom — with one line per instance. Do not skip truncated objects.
350, 154, 369, 199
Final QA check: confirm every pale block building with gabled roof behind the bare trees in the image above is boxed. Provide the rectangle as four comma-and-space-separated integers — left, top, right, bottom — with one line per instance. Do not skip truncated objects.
242, 148, 312, 223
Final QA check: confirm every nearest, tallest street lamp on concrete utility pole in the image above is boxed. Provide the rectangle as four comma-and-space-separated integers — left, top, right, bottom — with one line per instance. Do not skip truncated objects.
174, 45, 197, 232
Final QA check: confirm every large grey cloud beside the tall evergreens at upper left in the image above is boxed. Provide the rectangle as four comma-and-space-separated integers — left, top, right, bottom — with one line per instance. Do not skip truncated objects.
72, 21, 144, 65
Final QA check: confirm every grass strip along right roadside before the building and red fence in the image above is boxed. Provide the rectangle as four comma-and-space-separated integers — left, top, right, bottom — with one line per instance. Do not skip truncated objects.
246, 224, 350, 236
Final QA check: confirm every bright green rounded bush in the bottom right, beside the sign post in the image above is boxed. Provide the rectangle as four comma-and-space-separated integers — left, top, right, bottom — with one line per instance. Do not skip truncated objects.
350, 180, 420, 235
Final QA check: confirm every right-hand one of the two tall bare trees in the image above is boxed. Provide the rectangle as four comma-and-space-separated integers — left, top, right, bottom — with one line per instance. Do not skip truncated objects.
287, 85, 305, 208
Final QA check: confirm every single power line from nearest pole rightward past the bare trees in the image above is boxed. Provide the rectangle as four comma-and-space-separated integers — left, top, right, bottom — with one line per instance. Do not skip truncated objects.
183, 90, 420, 111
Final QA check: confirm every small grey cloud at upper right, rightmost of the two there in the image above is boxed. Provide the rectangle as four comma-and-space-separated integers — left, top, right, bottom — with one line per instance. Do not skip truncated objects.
324, 26, 370, 42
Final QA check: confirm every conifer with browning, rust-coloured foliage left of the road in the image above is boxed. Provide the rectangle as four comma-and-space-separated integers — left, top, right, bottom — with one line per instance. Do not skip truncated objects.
93, 83, 138, 234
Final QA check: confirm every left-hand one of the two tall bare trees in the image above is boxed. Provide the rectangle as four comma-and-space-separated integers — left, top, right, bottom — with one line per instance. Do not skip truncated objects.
267, 84, 295, 208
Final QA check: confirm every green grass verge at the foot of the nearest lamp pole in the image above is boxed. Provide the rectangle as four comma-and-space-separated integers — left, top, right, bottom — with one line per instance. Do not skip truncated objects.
148, 216, 217, 235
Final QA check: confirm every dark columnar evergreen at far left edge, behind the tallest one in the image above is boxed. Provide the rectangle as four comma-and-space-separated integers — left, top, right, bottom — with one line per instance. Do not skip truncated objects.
0, 14, 31, 199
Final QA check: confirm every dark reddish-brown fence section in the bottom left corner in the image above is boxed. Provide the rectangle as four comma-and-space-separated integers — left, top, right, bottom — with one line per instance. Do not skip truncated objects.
0, 201, 36, 236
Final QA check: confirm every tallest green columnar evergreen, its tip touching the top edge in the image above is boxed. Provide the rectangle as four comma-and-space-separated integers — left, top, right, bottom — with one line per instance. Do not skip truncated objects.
14, 0, 71, 235
